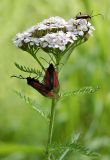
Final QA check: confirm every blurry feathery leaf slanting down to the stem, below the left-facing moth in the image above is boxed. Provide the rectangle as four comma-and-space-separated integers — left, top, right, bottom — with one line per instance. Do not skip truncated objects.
14, 90, 49, 121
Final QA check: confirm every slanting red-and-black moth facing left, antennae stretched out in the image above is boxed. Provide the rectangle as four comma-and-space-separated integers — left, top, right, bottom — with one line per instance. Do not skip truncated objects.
11, 75, 56, 98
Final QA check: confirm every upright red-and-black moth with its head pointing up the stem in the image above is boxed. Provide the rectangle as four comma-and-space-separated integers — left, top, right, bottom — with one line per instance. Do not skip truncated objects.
44, 63, 59, 92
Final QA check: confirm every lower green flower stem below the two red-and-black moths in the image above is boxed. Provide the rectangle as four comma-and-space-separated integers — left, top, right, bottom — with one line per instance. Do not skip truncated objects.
46, 99, 56, 160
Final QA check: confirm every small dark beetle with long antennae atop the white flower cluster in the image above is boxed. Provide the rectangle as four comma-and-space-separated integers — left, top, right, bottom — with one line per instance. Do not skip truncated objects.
75, 12, 103, 19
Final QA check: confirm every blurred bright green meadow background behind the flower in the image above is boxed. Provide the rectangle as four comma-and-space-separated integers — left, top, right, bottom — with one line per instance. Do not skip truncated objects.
0, 0, 110, 160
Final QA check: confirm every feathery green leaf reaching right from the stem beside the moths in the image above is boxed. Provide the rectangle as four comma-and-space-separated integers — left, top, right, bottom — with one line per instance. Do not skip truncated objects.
60, 86, 100, 100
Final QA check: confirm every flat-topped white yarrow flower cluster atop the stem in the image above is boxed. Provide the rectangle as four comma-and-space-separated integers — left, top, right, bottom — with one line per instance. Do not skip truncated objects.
13, 17, 94, 52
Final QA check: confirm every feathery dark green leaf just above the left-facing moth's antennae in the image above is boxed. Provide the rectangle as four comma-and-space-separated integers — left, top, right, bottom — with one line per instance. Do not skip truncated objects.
15, 62, 42, 77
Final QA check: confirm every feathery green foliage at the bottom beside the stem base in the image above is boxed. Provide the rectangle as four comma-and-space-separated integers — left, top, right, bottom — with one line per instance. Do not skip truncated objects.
50, 134, 99, 160
